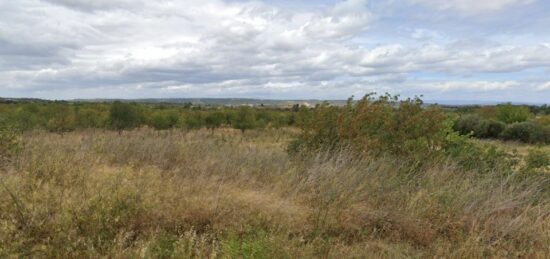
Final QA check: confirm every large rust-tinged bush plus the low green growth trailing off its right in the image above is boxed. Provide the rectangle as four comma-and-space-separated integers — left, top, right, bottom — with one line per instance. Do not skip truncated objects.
288, 95, 517, 172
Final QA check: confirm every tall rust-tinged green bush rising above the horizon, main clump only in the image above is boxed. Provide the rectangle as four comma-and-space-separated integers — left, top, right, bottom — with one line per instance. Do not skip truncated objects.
289, 95, 452, 160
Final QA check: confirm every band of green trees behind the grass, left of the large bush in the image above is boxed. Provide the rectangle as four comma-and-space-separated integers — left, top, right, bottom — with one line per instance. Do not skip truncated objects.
0, 102, 296, 133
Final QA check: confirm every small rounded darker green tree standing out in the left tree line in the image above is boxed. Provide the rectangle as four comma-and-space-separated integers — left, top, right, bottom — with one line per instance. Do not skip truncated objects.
109, 101, 141, 133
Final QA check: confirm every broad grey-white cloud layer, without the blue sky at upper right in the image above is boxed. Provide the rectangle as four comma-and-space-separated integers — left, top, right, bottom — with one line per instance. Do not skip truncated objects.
0, 0, 550, 102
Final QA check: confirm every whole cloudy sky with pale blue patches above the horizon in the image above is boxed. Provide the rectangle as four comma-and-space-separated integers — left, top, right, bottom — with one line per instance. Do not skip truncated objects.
0, 0, 550, 103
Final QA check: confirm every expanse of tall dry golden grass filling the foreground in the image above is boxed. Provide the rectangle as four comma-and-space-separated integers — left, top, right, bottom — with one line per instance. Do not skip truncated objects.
0, 129, 550, 258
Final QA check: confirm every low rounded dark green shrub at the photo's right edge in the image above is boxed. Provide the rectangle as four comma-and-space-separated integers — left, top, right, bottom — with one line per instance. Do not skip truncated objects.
501, 122, 548, 143
